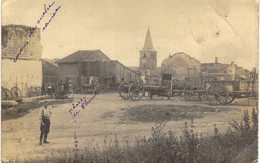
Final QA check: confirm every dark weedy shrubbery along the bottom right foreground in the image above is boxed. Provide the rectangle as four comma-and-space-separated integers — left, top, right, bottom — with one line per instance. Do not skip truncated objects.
22, 108, 258, 163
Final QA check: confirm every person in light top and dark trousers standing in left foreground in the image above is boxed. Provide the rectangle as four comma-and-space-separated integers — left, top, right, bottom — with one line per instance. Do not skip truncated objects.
39, 104, 51, 145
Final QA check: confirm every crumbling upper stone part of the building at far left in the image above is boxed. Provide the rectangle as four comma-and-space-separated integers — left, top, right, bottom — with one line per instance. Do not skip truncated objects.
2, 25, 42, 60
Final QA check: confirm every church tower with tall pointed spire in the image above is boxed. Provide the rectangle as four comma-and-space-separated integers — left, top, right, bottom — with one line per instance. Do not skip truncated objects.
139, 28, 157, 72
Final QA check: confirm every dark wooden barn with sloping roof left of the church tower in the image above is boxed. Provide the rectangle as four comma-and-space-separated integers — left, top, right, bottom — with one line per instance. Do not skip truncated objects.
56, 50, 139, 90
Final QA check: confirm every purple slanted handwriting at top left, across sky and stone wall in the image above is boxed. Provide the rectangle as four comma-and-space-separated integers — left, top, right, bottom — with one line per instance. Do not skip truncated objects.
13, 1, 61, 63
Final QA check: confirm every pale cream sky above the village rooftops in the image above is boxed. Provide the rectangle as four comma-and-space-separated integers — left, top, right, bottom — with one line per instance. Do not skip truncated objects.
2, 0, 258, 69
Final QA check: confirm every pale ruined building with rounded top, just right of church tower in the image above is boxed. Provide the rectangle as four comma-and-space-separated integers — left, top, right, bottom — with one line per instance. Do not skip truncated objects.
161, 52, 200, 80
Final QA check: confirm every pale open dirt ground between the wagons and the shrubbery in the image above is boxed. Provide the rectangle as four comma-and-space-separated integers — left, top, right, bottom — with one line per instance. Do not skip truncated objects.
2, 93, 256, 161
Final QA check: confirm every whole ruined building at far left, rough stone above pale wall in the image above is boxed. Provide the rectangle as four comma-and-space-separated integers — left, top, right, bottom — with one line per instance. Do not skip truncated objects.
1, 25, 42, 96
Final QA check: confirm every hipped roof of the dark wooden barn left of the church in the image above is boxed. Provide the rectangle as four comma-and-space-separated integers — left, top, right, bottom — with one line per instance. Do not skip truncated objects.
56, 50, 110, 64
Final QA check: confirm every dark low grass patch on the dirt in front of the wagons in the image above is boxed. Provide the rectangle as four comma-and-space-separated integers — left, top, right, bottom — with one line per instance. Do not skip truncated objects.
121, 105, 227, 122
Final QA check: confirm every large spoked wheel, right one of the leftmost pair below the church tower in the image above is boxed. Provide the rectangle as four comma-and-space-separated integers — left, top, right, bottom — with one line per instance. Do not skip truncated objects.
128, 82, 144, 101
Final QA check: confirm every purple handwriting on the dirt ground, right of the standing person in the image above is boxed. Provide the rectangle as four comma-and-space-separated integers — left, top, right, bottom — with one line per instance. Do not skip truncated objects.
69, 93, 97, 117
